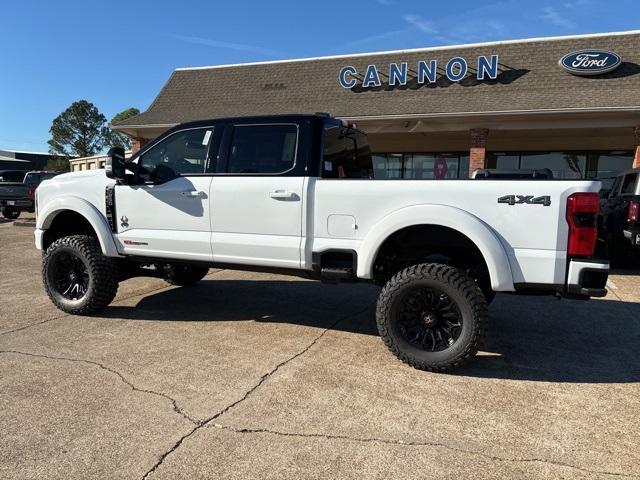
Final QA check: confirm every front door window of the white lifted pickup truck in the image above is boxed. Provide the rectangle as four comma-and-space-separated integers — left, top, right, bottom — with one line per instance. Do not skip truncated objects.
138, 128, 213, 182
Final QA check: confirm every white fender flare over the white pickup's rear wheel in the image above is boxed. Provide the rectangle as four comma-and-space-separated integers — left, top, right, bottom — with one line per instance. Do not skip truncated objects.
358, 204, 515, 291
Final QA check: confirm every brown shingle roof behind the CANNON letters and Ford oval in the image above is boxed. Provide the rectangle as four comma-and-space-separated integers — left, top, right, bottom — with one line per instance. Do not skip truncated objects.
118, 32, 640, 127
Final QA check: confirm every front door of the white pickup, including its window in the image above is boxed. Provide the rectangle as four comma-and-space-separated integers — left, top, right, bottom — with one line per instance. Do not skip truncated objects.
115, 127, 214, 261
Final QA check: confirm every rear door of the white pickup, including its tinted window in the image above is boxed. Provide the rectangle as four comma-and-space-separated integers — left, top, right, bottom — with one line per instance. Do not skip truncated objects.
210, 123, 306, 268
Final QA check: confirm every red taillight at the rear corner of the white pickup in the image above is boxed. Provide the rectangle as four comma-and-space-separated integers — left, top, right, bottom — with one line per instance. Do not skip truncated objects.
567, 193, 600, 256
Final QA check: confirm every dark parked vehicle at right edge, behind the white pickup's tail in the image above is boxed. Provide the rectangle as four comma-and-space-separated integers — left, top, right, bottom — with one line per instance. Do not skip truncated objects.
598, 168, 640, 266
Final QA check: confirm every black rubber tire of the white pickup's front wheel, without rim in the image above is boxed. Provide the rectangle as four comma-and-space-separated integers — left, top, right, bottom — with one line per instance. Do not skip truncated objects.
42, 235, 119, 315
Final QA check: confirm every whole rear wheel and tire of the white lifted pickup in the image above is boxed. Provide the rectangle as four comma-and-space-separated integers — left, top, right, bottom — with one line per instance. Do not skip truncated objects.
376, 263, 488, 372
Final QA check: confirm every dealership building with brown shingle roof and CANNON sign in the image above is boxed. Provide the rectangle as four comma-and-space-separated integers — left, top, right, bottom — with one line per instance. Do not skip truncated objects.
114, 31, 640, 178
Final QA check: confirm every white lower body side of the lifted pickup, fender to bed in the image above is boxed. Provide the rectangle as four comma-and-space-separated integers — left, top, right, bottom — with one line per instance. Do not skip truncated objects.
36, 170, 600, 291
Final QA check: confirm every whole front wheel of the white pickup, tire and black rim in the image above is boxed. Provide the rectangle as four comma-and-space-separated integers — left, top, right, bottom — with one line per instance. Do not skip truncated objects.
42, 235, 118, 315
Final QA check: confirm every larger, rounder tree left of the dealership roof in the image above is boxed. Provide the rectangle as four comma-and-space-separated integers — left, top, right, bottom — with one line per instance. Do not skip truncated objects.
48, 100, 109, 158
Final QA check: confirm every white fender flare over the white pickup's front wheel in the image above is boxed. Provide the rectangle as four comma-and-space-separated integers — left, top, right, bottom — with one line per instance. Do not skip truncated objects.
36, 195, 120, 257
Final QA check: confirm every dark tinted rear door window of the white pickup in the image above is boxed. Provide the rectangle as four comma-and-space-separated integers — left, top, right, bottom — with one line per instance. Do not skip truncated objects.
227, 125, 298, 174
